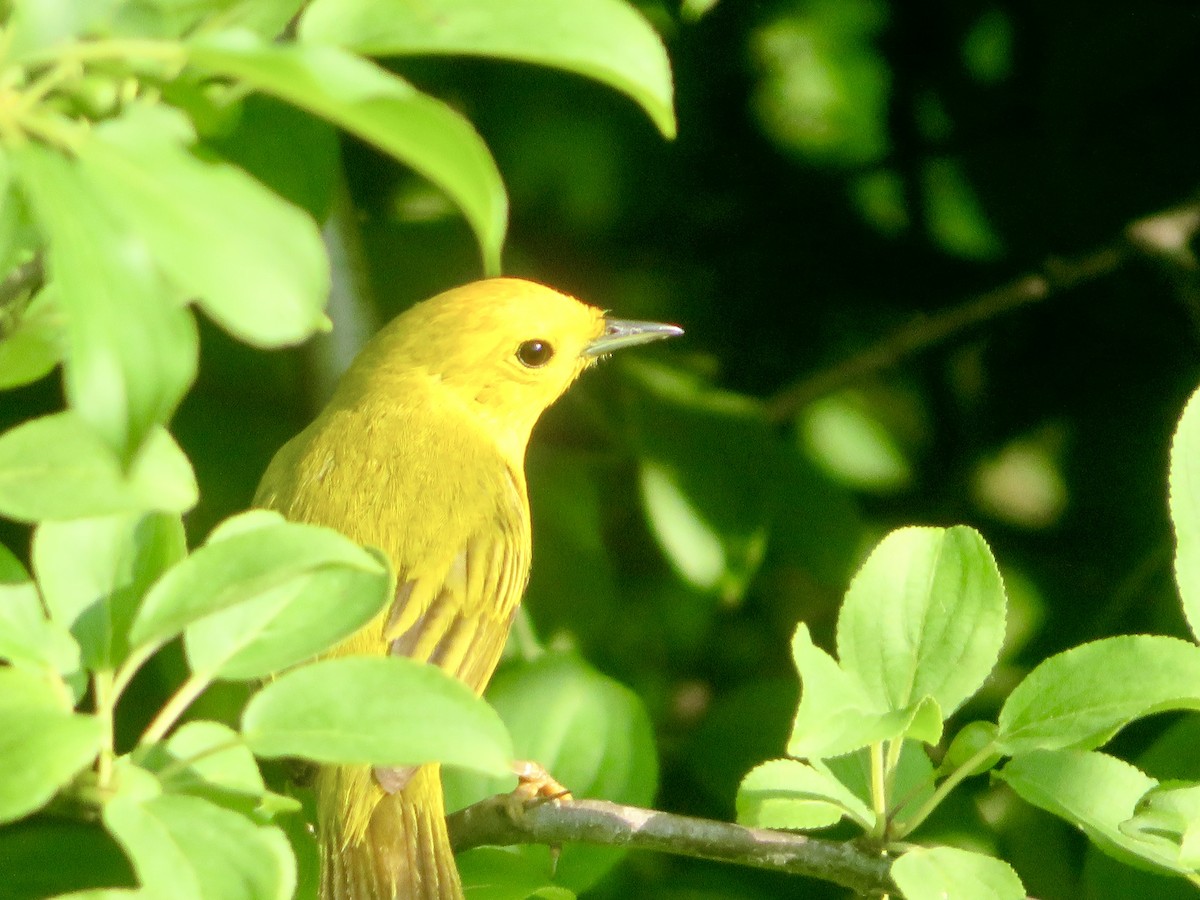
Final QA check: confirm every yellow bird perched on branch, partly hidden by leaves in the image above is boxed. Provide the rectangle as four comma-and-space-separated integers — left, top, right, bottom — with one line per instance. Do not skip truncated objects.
254, 278, 682, 900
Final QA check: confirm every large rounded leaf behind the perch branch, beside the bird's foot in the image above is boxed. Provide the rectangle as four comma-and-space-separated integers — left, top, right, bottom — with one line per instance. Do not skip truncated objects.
445, 652, 658, 893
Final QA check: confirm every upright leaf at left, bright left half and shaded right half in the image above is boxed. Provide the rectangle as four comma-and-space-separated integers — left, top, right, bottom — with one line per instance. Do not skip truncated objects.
32, 512, 187, 668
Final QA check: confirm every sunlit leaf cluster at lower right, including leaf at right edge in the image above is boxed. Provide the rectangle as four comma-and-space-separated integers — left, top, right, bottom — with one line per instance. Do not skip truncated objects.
738, 384, 1200, 900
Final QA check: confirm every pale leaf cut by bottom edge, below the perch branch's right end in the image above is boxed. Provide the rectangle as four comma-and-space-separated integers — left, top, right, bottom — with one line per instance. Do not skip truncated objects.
892, 847, 1026, 900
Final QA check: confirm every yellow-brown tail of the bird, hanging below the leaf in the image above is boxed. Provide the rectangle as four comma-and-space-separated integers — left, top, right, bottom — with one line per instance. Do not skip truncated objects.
317, 766, 463, 900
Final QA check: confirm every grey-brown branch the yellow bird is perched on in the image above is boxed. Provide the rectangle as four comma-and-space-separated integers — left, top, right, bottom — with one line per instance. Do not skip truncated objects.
448, 794, 896, 895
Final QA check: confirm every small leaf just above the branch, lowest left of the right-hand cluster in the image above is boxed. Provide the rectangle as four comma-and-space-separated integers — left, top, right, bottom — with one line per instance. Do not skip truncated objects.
737, 760, 875, 830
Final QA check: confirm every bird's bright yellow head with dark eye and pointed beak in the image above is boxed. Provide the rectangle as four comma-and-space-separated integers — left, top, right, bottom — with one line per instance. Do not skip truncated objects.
338, 278, 683, 452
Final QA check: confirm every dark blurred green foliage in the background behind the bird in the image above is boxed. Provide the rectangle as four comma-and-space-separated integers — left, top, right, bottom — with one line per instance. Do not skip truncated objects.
0, 0, 1200, 900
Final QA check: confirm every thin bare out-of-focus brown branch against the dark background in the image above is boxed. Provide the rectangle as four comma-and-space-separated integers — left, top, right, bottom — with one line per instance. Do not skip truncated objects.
767, 203, 1200, 421
